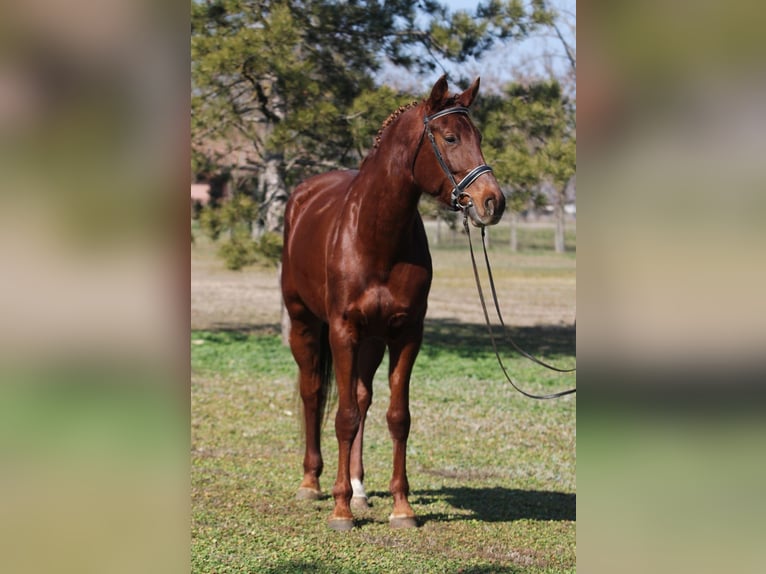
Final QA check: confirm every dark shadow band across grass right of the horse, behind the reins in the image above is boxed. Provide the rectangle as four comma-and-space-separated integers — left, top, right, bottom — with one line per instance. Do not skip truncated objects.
420, 319, 577, 357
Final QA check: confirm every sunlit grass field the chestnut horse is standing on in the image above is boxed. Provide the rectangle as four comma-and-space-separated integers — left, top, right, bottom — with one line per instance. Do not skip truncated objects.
191, 218, 576, 573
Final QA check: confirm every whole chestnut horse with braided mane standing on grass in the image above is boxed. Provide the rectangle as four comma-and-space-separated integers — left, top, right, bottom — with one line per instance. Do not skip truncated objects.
282, 77, 505, 530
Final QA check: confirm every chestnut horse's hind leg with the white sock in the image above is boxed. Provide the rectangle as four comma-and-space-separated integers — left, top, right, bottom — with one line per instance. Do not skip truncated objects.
351, 339, 386, 509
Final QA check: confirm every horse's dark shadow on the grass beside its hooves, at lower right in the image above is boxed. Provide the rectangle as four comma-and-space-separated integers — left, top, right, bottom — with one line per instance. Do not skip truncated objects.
413, 487, 577, 523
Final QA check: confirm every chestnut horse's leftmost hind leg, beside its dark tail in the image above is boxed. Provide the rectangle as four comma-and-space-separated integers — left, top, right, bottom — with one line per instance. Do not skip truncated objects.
290, 315, 329, 500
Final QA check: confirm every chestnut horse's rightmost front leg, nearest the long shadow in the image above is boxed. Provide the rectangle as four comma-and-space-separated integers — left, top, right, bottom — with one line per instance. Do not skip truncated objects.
386, 323, 423, 528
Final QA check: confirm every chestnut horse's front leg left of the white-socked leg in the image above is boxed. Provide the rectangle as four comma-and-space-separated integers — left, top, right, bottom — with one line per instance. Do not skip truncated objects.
329, 320, 361, 530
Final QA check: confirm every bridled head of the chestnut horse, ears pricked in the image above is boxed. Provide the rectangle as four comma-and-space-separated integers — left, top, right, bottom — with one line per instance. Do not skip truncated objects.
412, 76, 505, 226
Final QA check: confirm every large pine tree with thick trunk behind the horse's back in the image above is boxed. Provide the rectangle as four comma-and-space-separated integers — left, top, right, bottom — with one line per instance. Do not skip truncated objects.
191, 0, 551, 268
